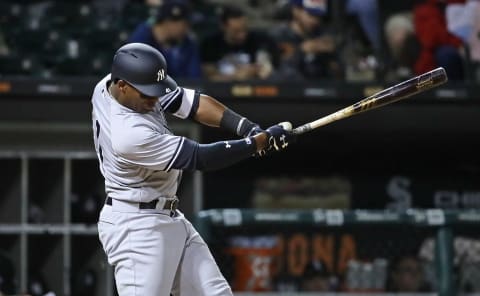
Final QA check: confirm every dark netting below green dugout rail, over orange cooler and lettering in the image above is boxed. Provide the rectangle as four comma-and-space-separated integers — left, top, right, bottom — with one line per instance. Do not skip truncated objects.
208, 224, 480, 293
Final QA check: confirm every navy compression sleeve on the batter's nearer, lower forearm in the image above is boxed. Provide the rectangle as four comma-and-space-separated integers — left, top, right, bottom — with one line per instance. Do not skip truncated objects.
171, 137, 256, 171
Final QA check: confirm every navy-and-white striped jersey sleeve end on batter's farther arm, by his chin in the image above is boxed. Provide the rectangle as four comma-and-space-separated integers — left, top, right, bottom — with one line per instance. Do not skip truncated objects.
160, 87, 200, 119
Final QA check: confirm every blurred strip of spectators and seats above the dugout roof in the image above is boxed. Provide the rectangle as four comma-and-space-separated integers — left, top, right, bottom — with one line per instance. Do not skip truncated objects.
0, 0, 480, 81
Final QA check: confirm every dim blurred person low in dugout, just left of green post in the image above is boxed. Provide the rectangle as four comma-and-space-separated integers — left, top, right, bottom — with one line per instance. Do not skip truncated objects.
387, 254, 430, 292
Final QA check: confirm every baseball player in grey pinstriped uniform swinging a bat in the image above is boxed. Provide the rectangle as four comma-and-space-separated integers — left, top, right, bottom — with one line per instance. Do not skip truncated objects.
92, 43, 294, 296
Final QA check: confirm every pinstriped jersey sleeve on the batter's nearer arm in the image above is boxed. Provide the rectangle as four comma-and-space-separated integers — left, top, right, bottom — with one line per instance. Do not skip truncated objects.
112, 123, 185, 171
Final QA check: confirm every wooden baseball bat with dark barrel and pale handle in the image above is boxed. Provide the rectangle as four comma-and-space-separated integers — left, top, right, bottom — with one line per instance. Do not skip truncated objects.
292, 68, 448, 135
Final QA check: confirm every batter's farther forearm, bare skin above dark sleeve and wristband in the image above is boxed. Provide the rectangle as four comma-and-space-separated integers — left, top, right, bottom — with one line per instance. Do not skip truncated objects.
194, 95, 258, 137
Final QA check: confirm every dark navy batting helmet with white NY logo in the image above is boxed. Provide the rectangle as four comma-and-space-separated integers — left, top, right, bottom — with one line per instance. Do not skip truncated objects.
111, 43, 177, 97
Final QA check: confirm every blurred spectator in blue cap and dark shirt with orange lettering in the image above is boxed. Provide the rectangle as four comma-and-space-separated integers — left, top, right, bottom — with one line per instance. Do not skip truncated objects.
272, 0, 342, 79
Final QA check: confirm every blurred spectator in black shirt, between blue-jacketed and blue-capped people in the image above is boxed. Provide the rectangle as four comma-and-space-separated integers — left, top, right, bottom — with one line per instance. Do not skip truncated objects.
201, 6, 278, 81
